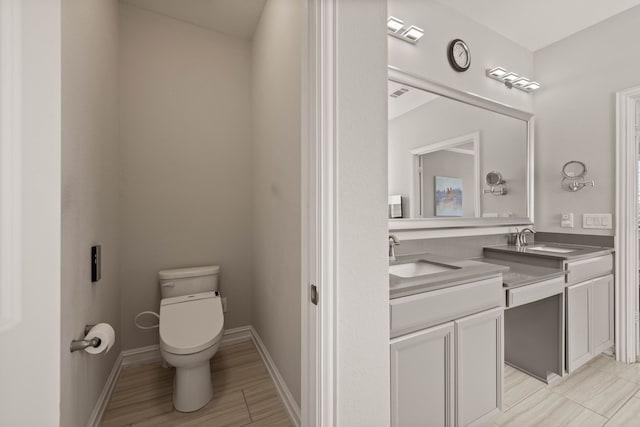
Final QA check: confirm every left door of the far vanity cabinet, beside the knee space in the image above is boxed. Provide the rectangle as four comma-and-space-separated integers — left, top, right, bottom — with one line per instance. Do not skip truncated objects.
567, 281, 592, 373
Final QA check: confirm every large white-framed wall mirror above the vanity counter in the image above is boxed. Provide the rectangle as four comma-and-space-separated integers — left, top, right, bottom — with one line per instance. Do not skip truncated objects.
389, 67, 533, 230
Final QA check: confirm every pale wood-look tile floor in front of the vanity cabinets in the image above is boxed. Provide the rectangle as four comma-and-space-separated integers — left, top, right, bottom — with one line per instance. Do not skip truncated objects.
494, 355, 640, 427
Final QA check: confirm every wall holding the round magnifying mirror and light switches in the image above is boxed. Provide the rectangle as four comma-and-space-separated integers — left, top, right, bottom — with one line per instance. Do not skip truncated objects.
534, 7, 640, 235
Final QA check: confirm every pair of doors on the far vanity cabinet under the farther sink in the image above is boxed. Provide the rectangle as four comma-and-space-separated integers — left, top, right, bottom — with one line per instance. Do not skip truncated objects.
567, 274, 614, 373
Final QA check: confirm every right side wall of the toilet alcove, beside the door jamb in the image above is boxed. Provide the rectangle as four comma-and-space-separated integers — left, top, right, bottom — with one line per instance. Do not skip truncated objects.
251, 0, 303, 405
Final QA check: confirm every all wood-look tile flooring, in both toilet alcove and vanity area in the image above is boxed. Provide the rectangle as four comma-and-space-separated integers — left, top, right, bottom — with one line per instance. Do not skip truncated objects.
102, 341, 640, 427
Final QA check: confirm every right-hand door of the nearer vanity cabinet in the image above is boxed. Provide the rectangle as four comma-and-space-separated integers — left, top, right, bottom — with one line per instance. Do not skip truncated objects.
455, 308, 504, 427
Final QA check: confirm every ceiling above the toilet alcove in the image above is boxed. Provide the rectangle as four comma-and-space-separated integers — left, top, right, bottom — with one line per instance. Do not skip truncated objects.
122, 0, 266, 40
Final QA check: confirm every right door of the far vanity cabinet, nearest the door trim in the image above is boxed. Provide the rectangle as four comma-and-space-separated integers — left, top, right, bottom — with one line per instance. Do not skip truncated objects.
591, 275, 614, 356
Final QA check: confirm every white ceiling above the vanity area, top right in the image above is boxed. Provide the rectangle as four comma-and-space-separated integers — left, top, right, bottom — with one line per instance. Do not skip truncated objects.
438, 0, 640, 51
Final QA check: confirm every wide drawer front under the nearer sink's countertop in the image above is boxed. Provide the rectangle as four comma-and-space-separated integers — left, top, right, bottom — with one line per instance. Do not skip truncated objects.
390, 275, 504, 338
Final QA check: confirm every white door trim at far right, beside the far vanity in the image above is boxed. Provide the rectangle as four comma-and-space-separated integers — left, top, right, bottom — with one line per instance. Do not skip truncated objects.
614, 86, 640, 363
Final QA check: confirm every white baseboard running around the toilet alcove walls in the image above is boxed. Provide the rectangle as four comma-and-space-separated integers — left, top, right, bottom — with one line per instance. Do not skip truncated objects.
87, 326, 300, 427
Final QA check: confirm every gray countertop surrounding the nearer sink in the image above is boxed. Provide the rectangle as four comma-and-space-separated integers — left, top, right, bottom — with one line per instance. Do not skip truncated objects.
389, 253, 509, 299
